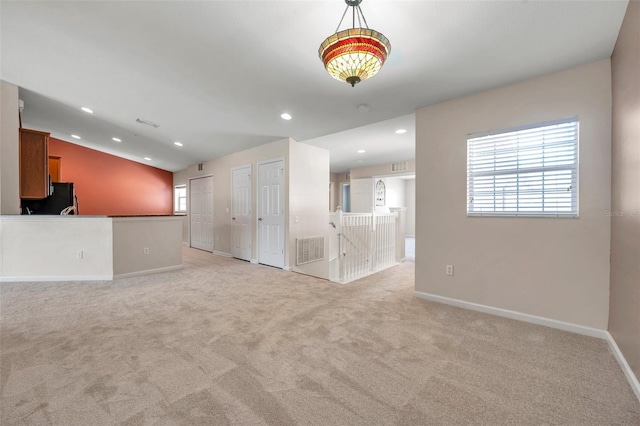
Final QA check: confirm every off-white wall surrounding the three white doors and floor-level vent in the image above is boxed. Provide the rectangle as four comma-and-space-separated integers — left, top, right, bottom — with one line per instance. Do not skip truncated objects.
179, 138, 330, 279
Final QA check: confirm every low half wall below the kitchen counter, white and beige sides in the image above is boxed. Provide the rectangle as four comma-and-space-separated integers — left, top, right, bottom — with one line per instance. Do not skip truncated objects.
0, 215, 182, 281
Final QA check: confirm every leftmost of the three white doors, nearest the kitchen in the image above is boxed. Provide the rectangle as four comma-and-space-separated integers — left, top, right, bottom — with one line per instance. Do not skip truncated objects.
189, 176, 213, 252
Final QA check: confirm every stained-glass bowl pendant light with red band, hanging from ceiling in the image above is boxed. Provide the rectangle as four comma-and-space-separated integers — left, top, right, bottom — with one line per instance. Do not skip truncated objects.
318, 0, 391, 87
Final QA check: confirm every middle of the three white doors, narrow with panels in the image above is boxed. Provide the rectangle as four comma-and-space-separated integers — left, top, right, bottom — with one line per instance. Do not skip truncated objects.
231, 166, 253, 260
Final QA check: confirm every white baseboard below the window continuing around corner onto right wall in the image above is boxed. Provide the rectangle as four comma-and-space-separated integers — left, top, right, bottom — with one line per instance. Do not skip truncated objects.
413, 291, 640, 401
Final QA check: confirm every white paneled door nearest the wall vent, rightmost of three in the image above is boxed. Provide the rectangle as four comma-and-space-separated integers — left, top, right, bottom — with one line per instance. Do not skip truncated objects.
258, 160, 284, 268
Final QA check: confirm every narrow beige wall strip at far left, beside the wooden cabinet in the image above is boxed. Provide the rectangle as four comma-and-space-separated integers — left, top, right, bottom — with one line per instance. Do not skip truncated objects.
0, 81, 20, 215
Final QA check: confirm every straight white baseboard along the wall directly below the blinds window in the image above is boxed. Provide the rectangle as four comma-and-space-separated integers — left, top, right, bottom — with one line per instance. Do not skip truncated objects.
413, 291, 608, 339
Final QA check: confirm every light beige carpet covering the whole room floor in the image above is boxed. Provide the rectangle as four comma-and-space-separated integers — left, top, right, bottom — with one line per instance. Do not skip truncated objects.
0, 249, 640, 426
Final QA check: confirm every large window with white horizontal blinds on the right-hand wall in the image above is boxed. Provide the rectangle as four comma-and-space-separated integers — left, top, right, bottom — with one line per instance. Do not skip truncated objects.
467, 117, 579, 217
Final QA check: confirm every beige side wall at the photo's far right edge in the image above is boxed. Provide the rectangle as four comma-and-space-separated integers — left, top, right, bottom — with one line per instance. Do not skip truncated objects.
609, 1, 640, 378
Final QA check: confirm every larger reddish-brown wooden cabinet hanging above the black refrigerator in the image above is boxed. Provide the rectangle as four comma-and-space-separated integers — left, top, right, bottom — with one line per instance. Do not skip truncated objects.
20, 129, 49, 200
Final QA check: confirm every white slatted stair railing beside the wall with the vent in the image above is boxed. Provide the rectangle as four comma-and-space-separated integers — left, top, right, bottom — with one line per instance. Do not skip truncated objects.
330, 207, 400, 283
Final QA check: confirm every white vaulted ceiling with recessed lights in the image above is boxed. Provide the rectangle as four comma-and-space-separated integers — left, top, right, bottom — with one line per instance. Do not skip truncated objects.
0, 0, 627, 172
